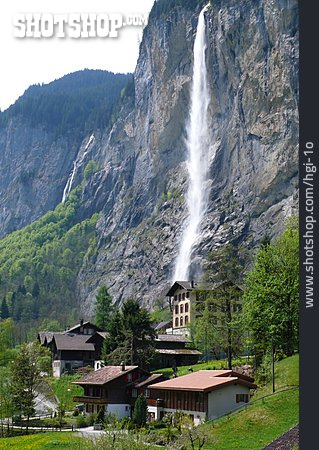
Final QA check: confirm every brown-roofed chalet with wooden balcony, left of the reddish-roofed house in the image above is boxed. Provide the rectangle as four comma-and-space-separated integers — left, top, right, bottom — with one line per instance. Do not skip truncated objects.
74, 364, 164, 418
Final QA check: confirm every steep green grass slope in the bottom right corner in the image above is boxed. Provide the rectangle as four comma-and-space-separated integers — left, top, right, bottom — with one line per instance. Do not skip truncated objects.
203, 355, 299, 450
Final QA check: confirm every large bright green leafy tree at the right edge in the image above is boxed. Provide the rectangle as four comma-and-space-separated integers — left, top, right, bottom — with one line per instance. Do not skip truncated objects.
244, 220, 299, 361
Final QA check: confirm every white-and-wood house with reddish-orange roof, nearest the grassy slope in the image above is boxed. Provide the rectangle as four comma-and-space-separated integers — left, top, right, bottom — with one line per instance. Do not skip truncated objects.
148, 370, 257, 424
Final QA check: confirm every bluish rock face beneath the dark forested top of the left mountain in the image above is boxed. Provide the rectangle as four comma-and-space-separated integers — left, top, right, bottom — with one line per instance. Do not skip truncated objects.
0, 117, 78, 237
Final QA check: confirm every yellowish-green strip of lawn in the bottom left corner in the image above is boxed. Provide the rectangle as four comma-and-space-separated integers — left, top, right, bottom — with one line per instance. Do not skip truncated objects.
0, 431, 88, 450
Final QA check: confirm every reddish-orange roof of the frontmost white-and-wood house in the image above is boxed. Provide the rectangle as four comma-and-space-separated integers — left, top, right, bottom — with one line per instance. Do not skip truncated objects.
149, 370, 257, 392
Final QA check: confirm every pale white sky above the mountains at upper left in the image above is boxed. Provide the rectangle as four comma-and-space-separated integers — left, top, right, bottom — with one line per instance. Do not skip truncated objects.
0, 0, 154, 111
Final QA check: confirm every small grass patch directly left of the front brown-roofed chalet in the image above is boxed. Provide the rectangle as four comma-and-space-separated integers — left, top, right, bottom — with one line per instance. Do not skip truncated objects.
48, 375, 83, 411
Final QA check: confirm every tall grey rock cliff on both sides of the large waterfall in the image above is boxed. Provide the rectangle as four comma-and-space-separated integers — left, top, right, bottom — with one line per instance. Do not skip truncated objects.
79, 0, 298, 308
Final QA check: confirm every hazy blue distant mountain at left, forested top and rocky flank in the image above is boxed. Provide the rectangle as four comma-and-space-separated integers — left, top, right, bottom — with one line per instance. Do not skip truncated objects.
0, 70, 131, 237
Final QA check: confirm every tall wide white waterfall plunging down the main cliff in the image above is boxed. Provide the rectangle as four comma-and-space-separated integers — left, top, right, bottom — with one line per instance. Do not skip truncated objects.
173, 6, 210, 281
